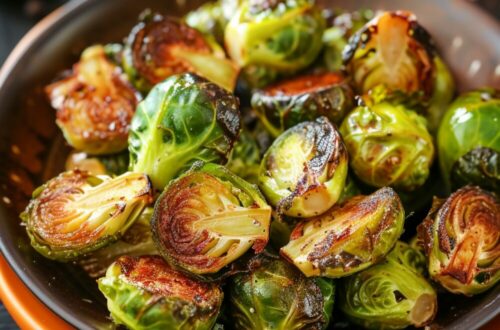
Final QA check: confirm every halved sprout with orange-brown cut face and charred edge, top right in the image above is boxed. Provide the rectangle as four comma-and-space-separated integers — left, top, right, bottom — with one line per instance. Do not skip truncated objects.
343, 11, 435, 99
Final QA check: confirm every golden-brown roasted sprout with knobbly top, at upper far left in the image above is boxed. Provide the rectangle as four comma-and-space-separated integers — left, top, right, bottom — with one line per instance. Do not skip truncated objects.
45, 45, 139, 155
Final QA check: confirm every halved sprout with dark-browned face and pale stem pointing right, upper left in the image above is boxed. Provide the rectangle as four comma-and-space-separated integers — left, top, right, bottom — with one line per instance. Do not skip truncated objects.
123, 12, 238, 92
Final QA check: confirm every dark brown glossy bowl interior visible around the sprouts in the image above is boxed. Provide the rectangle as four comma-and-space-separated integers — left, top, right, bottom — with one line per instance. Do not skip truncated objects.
0, 0, 500, 329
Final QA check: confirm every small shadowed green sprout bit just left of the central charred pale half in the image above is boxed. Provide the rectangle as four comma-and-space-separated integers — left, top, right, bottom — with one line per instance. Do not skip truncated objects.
226, 128, 261, 184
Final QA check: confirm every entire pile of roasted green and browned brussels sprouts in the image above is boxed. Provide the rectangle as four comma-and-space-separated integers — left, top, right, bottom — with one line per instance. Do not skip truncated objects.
21, 0, 500, 329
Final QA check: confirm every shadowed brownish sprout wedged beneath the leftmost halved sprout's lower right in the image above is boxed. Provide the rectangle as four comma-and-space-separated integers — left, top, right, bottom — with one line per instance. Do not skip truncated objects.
77, 207, 159, 278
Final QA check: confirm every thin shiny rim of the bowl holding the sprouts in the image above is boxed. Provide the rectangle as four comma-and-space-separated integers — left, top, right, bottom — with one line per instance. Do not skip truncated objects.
0, 0, 500, 329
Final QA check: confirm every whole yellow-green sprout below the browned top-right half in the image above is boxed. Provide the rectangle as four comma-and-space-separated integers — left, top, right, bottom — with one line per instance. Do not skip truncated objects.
340, 102, 434, 191
